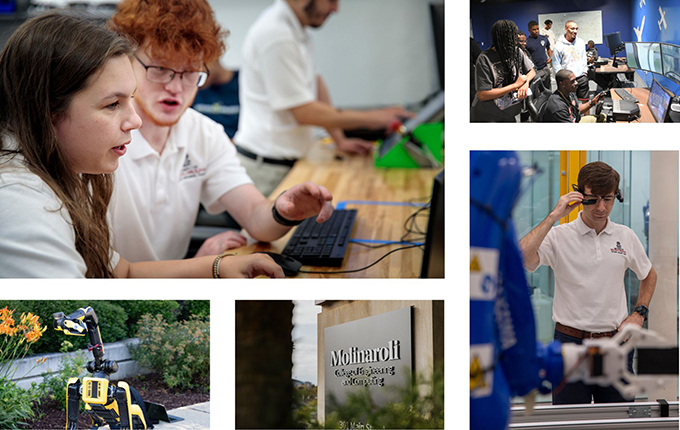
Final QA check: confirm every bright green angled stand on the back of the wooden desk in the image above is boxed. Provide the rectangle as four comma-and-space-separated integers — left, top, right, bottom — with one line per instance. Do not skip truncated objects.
374, 122, 444, 168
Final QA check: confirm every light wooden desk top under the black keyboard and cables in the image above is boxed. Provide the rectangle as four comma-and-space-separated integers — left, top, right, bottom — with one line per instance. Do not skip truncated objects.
235, 145, 439, 278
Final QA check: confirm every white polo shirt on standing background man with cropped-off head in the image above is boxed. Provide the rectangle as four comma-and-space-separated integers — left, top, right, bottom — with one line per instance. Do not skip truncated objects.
234, 0, 317, 159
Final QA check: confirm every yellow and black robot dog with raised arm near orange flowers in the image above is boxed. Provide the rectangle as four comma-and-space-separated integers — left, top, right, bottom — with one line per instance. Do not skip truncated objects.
52, 306, 153, 430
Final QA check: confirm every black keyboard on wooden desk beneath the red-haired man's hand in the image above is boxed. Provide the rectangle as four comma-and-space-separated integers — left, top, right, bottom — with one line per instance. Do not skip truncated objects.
281, 209, 357, 266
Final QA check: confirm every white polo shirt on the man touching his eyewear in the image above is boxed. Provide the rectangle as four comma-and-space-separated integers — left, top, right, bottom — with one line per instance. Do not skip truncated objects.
538, 213, 652, 332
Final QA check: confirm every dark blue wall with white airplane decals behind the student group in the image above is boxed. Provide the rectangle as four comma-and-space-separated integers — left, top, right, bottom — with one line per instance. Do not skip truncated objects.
470, 0, 680, 94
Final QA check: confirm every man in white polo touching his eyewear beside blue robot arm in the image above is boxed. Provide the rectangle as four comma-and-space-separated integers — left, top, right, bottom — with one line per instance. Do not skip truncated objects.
519, 161, 656, 404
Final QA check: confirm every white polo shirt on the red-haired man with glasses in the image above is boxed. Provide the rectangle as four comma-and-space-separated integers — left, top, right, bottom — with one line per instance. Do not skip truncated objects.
109, 109, 252, 262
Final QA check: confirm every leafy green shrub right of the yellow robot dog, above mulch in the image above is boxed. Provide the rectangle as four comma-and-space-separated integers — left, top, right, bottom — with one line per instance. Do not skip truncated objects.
132, 315, 210, 389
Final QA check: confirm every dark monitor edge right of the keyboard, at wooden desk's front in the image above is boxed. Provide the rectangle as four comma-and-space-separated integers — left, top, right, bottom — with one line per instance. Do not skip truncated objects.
420, 170, 444, 278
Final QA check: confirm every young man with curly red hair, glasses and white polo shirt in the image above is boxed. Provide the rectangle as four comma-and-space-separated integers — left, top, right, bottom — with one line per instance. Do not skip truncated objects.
109, 0, 333, 261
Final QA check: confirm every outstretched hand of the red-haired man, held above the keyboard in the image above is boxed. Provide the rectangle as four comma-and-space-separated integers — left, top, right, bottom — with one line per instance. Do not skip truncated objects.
274, 181, 333, 222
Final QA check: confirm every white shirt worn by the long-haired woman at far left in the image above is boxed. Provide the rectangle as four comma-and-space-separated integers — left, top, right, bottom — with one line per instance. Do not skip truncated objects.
0, 137, 119, 278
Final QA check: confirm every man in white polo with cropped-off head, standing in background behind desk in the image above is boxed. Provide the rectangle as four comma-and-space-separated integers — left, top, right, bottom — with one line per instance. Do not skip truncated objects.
234, 0, 412, 195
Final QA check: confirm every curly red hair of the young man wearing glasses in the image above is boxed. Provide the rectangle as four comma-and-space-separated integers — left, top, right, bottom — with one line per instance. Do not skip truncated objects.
109, 0, 229, 64
